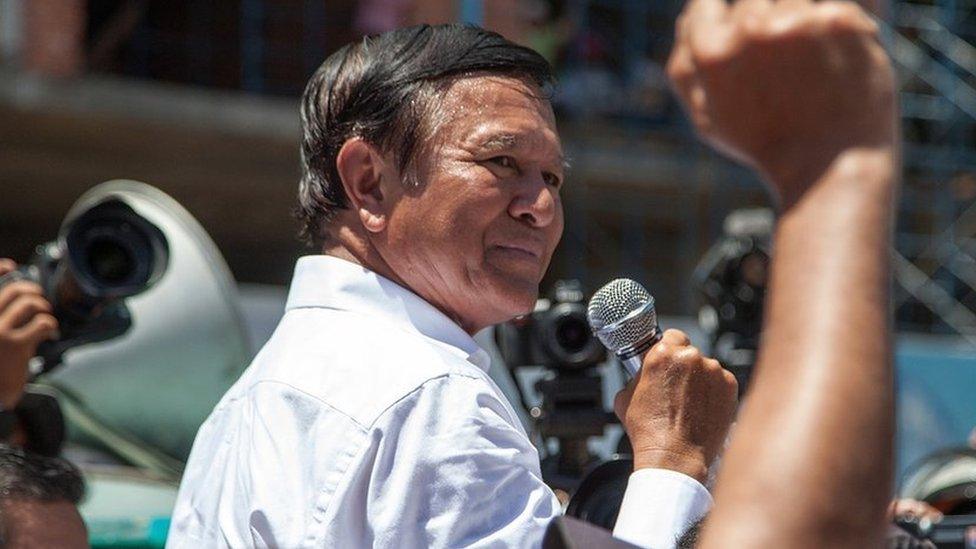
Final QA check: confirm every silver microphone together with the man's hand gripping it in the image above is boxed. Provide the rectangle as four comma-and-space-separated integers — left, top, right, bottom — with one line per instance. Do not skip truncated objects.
586, 278, 738, 484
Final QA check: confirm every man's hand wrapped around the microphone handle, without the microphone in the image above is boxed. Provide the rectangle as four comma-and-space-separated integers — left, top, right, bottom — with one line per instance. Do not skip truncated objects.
614, 330, 738, 483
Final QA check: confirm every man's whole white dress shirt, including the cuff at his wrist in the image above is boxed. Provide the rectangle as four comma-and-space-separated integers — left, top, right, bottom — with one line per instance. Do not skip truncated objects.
167, 256, 711, 548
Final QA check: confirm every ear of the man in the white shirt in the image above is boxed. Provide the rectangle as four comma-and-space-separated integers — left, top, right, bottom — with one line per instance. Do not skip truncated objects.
336, 137, 391, 233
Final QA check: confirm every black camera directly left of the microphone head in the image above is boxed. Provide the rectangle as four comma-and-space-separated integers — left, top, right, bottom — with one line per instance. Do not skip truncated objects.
495, 280, 607, 372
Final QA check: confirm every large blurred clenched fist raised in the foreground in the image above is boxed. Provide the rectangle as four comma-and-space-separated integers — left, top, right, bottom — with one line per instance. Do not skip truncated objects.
668, 0, 897, 206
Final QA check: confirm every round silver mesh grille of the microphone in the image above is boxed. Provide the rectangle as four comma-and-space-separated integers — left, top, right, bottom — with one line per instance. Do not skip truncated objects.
586, 278, 657, 352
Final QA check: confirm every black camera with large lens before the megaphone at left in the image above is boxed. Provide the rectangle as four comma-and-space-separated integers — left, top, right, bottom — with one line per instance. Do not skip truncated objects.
0, 199, 169, 375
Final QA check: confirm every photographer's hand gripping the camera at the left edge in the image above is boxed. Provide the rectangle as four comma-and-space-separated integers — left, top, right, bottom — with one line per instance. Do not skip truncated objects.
0, 259, 58, 410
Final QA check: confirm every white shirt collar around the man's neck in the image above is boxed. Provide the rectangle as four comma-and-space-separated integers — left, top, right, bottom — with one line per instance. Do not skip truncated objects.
285, 255, 491, 371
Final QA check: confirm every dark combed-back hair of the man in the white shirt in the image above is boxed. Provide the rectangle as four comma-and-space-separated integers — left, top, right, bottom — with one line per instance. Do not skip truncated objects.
296, 24, 553, 244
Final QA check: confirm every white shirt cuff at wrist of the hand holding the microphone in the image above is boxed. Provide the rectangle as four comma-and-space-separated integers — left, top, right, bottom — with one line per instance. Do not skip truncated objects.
613, 469, 712, 549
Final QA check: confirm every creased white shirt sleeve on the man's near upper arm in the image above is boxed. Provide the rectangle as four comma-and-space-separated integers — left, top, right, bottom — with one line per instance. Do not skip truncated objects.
358, 376, 561, 547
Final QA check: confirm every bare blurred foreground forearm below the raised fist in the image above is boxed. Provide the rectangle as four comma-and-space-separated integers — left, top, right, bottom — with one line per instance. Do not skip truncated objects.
703, 148, 897, 547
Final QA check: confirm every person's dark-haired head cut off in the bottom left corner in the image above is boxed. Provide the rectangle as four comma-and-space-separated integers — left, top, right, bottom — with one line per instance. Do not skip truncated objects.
0, 445, 88, 548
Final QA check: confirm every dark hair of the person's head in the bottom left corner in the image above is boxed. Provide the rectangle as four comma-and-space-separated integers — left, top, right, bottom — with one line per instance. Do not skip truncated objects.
0, 444, 85, 505
